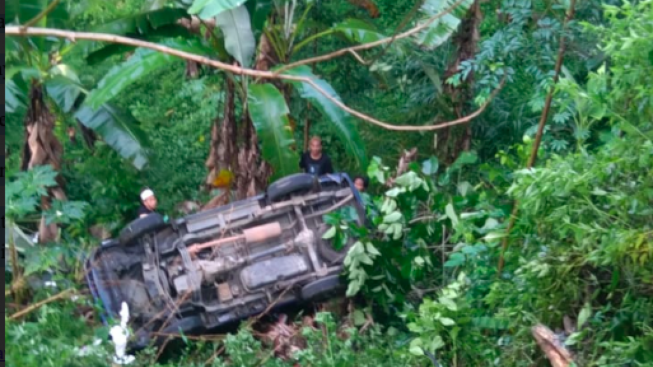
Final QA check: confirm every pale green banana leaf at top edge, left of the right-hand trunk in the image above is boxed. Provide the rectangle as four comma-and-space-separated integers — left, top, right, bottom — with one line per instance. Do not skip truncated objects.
415, 0, 474, 50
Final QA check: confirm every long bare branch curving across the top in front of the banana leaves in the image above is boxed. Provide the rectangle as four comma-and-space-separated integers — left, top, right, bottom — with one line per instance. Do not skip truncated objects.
5, 25, 506, 131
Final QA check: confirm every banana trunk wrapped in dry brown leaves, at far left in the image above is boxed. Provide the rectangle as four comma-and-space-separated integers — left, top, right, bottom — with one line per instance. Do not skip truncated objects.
21, 81, 66, 243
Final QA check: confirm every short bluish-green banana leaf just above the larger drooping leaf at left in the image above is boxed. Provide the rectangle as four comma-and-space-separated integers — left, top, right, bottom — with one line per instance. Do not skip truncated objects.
45, 64, 82, 113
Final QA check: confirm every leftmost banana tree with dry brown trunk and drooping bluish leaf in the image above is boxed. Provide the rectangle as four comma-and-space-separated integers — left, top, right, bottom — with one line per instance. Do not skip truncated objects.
5, 0, 147, 242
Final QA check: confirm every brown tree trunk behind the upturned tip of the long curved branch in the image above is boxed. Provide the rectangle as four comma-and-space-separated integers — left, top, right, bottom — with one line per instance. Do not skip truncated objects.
438, 0, 483, 164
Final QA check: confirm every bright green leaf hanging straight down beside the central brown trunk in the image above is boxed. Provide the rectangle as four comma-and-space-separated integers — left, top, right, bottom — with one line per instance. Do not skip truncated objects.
247, 84, 298, 180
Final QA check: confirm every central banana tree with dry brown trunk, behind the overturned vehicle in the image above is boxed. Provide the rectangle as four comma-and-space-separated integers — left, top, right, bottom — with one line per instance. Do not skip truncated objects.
85, 0, 471, 196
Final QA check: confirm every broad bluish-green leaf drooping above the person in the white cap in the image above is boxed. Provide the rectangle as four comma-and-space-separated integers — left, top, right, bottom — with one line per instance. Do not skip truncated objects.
75, 104, 148, 169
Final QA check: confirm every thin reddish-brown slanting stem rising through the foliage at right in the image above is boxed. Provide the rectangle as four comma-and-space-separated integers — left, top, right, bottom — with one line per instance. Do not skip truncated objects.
497, 0, 576, 277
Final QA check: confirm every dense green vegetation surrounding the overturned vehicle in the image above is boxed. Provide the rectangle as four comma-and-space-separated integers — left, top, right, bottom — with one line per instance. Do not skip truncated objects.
5, 0, 653, 366
